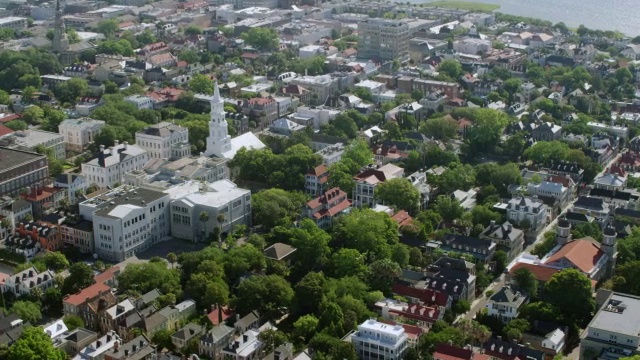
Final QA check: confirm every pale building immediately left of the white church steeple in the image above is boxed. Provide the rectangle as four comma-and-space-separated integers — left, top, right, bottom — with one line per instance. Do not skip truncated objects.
136, 121, 191, 160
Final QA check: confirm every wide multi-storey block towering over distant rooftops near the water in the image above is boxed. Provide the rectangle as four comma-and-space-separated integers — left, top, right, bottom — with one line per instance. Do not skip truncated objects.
358, 18, 409, 60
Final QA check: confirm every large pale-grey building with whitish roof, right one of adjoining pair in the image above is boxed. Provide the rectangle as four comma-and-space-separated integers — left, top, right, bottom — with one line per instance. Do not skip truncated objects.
165, 180, 251, 241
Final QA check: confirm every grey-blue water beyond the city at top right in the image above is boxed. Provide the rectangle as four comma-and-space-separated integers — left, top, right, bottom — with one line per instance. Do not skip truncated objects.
418, 0, 640, 36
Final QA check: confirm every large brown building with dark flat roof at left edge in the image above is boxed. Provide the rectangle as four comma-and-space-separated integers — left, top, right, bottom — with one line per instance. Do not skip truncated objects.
0, 147, 49, 196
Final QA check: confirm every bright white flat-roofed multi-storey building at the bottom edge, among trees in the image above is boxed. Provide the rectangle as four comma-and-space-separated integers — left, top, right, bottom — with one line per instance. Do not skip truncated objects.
351, 319, 408, 360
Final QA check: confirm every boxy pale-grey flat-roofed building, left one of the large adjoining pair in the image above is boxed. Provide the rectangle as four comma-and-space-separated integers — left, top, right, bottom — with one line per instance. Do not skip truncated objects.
80, 185, 171, 261
